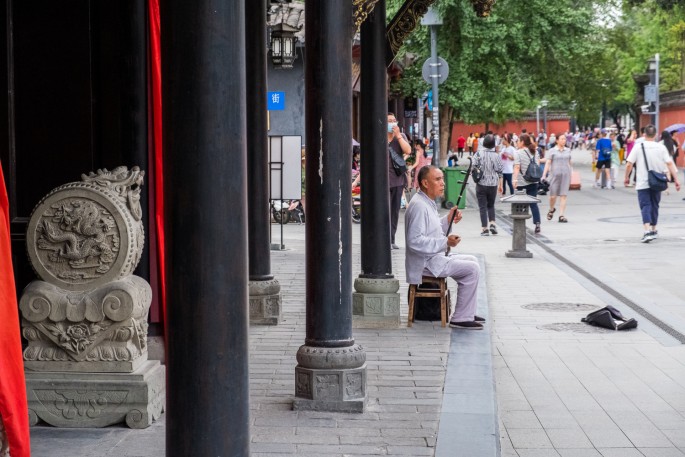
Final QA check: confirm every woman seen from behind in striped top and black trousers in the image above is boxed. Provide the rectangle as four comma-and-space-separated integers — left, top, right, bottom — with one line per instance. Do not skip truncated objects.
471, 134, 502, 236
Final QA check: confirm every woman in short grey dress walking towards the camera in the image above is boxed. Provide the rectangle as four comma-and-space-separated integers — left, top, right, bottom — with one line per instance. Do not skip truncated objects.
542, 135, 573, 223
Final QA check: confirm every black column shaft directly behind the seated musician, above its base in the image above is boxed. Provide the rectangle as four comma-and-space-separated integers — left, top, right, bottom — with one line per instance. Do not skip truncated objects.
360, 0, 393, 279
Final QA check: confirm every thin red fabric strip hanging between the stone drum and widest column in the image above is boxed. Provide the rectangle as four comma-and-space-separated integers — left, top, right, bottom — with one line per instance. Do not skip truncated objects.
148, 0, 166, 327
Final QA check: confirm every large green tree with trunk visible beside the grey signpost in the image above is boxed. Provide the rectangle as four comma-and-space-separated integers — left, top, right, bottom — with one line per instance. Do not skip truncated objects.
389, 0, 612, 154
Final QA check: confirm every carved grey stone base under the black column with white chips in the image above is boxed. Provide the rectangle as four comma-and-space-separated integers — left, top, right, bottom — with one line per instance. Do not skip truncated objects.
293, 344, 366, 413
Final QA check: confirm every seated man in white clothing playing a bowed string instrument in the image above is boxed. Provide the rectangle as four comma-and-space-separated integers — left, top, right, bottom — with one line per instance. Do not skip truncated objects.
404, 165, 485, 330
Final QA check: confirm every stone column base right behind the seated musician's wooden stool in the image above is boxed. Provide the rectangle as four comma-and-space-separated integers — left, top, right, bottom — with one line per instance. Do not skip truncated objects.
352, 278, 400, 328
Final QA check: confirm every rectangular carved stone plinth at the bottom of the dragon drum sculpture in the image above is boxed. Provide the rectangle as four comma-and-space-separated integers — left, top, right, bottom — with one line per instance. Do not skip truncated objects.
25, 360, 166, 428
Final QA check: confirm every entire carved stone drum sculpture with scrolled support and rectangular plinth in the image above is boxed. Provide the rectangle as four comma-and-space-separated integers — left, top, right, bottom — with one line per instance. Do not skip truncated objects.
19, 167, 165, 428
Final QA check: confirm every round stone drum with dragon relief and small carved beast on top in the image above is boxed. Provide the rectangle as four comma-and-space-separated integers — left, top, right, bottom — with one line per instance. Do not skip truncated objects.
26, 167, 145, 290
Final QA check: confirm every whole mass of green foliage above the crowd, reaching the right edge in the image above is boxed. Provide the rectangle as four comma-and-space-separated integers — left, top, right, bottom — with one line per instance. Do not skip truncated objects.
388, 0, 685, 146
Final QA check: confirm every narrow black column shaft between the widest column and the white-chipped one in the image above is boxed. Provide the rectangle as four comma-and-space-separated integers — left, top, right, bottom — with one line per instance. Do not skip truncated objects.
245, 0, 273, 281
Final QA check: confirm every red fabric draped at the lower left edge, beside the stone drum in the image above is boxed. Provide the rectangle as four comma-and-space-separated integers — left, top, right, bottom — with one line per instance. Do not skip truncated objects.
0, 167, 31, 457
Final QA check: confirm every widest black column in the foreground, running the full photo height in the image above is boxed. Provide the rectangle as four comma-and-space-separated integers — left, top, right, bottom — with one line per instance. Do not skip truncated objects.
161, 0, 250, 457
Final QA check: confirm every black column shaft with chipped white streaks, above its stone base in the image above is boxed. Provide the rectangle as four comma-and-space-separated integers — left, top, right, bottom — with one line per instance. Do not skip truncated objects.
305, 0, 354, 347
